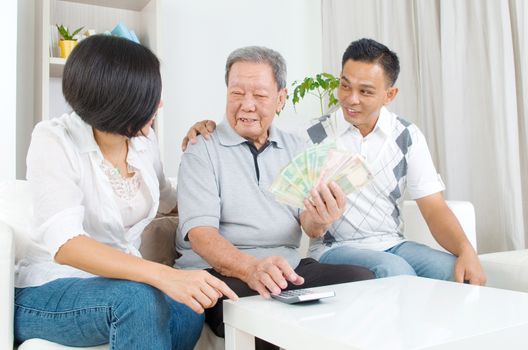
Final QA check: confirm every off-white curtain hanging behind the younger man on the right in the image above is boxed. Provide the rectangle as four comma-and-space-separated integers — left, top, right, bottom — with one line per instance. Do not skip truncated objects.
322, 0, 528, 253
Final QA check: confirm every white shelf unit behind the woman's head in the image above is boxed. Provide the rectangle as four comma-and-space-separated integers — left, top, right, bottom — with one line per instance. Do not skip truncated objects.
35, 0, 161, 121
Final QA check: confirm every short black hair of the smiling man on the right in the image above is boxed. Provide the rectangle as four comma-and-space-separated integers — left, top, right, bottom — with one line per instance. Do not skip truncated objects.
341, 38, 400, 86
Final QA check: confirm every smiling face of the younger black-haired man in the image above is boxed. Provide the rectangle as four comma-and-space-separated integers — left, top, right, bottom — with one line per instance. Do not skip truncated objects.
337, 60, 398, 136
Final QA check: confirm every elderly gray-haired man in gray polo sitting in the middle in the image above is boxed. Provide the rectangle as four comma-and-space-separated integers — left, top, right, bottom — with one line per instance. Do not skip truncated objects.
176, 47, 374, 342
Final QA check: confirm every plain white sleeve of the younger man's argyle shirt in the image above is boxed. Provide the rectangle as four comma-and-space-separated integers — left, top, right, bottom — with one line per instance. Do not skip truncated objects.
407, 126, 445, 199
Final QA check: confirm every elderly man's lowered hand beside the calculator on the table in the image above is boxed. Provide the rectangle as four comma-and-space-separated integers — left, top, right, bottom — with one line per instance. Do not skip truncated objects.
244, 256, 304, 299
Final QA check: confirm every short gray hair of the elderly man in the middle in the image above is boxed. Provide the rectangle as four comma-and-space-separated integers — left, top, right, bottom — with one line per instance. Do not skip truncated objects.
225, 46, 286, 90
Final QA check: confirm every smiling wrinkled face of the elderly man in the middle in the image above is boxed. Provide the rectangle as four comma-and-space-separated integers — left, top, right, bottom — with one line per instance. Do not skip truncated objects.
226, 62, 287, 148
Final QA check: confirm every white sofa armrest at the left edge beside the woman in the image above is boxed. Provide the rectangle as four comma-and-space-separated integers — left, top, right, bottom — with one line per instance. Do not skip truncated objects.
0, 221, 15, 349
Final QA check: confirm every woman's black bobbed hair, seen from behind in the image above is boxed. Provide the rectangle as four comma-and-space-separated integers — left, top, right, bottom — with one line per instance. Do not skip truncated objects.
62, 35, 161, 137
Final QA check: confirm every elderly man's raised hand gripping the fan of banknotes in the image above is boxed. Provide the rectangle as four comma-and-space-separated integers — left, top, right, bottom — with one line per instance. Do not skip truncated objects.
301, 182, 346, 237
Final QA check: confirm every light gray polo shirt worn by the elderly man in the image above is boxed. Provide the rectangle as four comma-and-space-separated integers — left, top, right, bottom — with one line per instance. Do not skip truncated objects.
175, 120, 305, 269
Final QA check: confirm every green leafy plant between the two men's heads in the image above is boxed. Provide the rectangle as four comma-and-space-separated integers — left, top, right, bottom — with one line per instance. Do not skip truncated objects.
292, 73, 339, 116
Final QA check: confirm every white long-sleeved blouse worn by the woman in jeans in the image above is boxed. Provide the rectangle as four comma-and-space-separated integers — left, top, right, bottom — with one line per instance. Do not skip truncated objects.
15, 113, 176, 288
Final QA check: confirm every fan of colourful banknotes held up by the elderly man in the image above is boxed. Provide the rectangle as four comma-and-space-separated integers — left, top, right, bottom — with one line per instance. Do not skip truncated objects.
269, 143, 373, 209
